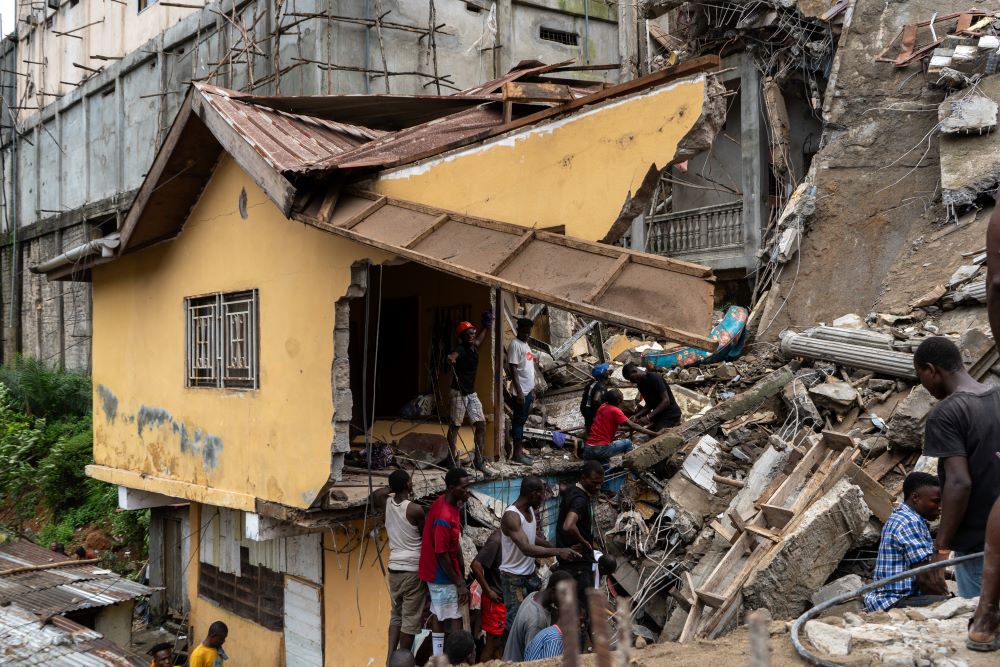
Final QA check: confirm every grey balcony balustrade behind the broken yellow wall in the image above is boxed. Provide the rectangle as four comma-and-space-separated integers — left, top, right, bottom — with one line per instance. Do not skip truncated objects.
646, 202, 743, 257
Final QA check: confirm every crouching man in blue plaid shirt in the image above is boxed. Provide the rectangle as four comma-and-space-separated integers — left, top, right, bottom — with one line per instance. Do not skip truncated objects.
865, 472, 948, 611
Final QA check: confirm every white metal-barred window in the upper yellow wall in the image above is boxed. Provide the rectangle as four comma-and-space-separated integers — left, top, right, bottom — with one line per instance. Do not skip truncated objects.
184, 290, 259, 389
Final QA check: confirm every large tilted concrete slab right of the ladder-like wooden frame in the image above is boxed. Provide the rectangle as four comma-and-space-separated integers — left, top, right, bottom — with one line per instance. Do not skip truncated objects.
743, 480, 871, 619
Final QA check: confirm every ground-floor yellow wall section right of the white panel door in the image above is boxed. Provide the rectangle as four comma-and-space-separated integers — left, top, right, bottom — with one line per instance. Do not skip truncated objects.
323, 521, 392, 667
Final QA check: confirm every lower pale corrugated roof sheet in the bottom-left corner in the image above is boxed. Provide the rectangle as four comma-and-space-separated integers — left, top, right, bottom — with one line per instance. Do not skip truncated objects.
0, 604, 148, 667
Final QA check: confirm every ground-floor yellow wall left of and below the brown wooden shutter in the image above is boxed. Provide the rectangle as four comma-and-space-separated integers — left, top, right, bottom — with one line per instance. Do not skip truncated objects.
186, 503, 286, 667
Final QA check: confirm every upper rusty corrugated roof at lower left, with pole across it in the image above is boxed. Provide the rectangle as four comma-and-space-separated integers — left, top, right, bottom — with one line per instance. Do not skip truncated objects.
0, 541, 153, 615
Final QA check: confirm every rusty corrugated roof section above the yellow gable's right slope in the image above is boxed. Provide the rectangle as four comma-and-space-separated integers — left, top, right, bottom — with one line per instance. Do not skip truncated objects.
195, 84, 385, 172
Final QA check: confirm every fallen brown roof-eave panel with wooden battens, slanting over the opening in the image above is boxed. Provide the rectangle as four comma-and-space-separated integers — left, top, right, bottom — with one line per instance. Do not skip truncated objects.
293, 191, 717, 350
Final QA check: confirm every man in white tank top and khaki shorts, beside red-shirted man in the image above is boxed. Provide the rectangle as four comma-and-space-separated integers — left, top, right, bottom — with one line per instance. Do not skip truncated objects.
372, 470, 427, 655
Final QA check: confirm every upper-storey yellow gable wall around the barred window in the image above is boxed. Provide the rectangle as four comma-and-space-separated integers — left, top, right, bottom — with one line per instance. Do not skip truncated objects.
93, 157, 386, 509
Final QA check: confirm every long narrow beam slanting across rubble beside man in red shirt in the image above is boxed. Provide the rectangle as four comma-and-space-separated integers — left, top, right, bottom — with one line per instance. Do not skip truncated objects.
623, 366, 794, 470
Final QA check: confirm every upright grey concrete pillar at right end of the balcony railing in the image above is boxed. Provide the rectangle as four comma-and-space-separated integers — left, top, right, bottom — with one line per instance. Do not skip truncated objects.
740, 54, 770, 280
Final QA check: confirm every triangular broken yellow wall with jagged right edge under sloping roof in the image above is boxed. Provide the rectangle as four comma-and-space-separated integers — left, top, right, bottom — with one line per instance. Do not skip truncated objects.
374, 76, 705, 241
